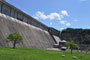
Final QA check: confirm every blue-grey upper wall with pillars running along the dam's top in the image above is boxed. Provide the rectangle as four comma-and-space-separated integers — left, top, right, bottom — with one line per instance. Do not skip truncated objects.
0, 0, 48, 31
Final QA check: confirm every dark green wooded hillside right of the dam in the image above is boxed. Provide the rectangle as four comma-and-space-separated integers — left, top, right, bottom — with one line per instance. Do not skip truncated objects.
61, 28, 90, 44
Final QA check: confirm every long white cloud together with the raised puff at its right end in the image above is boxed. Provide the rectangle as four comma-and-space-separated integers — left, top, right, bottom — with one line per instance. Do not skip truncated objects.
34, 10, 69, 20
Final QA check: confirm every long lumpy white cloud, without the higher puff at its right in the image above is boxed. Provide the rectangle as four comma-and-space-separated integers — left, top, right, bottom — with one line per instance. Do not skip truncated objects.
35, 11, 62, 20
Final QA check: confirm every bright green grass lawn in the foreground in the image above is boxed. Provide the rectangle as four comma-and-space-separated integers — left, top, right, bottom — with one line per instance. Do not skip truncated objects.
0, 47, 90, 60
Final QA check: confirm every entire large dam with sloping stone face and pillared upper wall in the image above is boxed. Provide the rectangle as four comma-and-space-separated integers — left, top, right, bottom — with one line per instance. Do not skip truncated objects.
0, 0, 60, 49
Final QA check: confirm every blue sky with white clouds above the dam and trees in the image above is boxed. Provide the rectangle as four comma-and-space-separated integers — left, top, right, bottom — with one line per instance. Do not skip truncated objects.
6, 0, 90, 30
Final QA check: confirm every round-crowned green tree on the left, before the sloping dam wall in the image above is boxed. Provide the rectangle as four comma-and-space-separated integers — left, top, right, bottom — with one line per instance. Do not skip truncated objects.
7, 33, 23, 48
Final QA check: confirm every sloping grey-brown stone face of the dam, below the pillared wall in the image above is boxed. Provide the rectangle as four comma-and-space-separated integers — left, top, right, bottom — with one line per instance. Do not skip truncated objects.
0, 13, 55, 49
